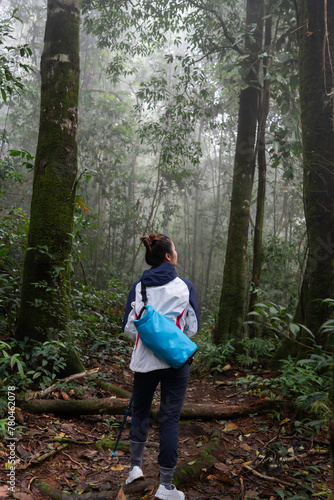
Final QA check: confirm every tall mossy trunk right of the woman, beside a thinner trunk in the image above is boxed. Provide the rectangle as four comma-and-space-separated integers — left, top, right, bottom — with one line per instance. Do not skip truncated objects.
216, 0, 264, 344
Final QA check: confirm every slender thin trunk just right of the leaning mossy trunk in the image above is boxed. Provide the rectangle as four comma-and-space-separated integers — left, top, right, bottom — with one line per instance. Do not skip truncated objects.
249, 16, 272, 320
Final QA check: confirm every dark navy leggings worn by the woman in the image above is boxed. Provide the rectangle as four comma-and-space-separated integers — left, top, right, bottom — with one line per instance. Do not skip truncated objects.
130, 363, 190, 468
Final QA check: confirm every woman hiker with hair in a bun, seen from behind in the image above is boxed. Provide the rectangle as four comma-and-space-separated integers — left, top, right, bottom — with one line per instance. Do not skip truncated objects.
122, 234, 199, 500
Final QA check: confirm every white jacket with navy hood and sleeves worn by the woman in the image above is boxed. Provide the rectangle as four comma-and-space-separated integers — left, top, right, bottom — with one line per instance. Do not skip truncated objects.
123, 262, 199, 373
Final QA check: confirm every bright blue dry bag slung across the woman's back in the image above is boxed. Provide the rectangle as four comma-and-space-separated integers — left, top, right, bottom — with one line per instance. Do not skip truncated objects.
134, 283, 197, 368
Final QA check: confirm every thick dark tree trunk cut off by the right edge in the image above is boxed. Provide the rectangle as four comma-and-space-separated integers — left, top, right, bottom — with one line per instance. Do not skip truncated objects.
299, 0, 334, 345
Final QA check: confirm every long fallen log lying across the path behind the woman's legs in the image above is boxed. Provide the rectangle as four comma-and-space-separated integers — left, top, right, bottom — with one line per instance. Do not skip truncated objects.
17, 398, 280, 420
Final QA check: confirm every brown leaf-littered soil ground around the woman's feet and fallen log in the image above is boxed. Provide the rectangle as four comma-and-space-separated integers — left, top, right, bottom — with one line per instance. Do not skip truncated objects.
0, 366, 330, 500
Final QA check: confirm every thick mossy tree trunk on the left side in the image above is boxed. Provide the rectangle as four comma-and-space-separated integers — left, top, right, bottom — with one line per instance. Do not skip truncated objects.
16, 0, 83, 373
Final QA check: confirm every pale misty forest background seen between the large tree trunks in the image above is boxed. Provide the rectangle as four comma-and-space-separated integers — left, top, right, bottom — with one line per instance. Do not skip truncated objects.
1, 2, 304, 320
